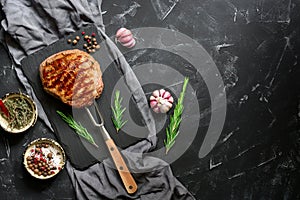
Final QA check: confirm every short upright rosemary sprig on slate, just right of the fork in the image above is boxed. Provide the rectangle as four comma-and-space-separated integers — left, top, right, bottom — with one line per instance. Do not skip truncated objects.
111, 90, 127, 132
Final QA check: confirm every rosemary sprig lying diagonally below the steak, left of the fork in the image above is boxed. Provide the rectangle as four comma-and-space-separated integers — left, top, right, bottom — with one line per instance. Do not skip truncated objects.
56, 110, 98, 148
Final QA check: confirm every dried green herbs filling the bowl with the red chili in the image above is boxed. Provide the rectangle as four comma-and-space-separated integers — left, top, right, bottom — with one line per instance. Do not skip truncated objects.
1, 95, 34, 129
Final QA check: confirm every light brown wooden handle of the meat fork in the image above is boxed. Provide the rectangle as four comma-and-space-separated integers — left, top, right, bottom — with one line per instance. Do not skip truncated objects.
105, 139, 137, 194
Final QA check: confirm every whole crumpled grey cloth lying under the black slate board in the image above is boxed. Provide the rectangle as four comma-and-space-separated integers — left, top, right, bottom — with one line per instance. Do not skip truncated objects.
0, 0, 194, 200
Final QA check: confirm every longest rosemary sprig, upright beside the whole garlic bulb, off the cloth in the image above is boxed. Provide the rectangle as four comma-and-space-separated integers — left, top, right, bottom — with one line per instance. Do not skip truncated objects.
164, 77, 189, 154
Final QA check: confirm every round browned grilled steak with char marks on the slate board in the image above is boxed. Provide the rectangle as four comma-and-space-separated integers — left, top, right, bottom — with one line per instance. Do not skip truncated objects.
39, 49, 104, 108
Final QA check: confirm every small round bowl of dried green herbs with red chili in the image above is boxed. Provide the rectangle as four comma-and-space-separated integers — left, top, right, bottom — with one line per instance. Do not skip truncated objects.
0, 92, 38, 133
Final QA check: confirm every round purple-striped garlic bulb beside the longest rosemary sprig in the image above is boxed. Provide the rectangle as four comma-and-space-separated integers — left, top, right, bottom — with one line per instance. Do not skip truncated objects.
150, 89, 174, 113
